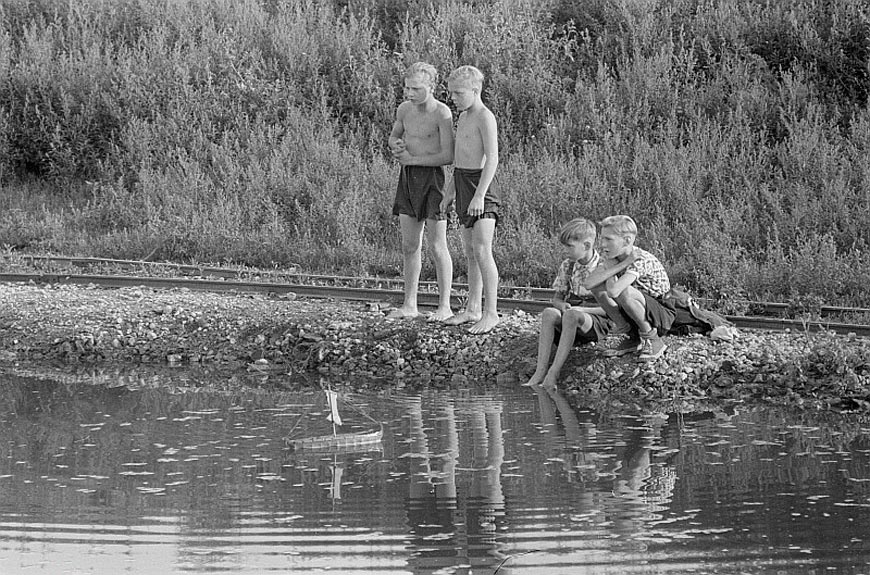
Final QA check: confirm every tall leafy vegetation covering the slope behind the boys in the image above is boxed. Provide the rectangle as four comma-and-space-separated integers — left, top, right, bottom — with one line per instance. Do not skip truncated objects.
0, 0, 870, 306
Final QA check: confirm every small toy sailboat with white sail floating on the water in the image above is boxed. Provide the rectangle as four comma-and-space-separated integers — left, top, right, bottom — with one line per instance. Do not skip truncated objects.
284, 389, 384, 453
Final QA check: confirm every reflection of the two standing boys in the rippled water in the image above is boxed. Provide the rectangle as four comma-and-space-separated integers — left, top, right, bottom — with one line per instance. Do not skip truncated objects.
400, 397, 507, 573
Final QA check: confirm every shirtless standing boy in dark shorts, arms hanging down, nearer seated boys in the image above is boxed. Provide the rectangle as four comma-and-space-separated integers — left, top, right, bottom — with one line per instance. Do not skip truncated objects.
442, 66, 500, 333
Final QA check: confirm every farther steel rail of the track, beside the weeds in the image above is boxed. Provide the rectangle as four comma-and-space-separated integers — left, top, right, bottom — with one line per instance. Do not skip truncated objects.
2, 254, 870, 325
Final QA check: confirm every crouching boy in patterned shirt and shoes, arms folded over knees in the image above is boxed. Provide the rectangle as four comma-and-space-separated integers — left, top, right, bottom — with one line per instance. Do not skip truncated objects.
584, 215, 674, 361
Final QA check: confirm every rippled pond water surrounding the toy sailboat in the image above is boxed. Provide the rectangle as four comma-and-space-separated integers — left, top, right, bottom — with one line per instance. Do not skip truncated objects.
0, 368, 870, 575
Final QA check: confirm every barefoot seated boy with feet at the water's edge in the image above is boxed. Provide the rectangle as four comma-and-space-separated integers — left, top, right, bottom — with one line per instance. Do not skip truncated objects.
526, 218, 611, 389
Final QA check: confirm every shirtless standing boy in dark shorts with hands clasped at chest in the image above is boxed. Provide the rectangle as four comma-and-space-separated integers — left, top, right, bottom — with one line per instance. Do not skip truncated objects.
389, 62, 453, 321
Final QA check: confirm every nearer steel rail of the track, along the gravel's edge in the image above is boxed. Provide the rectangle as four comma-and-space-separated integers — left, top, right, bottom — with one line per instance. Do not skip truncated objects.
0, 273, 870, 337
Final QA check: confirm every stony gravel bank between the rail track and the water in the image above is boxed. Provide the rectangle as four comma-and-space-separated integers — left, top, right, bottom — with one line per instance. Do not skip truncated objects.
0, 284, 870, 410
